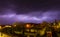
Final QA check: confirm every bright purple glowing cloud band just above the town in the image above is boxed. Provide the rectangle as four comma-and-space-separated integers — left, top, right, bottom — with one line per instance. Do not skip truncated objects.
0, 11, 59, 23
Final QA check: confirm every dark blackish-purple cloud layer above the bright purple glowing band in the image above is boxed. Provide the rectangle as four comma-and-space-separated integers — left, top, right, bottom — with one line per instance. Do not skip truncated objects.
0, 0, 60, 14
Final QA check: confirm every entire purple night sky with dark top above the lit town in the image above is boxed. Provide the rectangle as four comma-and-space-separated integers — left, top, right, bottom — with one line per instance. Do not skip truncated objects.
0, 0, 60, 24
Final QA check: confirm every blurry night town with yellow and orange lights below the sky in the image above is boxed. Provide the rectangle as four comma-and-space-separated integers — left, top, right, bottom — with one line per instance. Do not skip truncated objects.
0, 20, 60, 37
